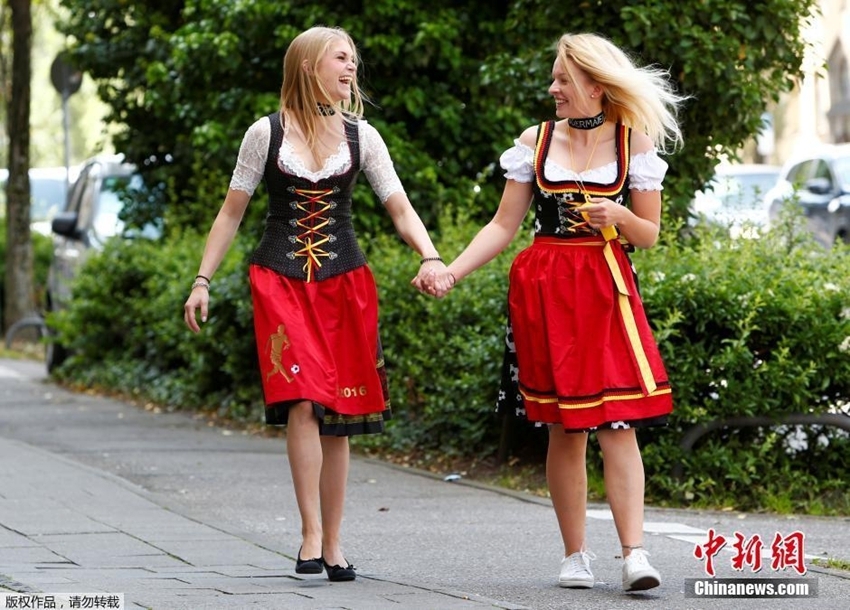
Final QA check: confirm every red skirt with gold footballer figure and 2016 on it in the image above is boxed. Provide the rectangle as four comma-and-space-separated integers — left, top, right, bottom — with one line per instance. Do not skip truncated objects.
249, 265, 391, 436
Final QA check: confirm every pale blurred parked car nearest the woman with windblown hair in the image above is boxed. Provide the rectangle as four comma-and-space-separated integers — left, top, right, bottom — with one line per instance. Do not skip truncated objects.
691, 163, 780, 238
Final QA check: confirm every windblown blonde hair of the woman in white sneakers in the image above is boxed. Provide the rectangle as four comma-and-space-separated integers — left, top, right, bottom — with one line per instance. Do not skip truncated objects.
557, 34, 687, 152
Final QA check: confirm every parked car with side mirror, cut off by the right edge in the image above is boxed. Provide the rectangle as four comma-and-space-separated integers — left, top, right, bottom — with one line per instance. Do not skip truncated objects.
765, 144, 850, 247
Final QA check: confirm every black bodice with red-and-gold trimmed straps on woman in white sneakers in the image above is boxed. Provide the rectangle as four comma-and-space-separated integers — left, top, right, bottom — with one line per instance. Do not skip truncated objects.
532, 121, 631, 239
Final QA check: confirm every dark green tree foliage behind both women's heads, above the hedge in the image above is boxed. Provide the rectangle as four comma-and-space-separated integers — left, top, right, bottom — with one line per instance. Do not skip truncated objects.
53, 0, 816, 231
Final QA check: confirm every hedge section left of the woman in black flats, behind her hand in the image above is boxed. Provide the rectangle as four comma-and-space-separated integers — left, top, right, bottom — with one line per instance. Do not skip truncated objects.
49, 228, 262, 419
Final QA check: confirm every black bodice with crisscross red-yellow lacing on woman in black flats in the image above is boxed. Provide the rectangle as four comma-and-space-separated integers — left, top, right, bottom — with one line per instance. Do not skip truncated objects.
251, 112, 366, 282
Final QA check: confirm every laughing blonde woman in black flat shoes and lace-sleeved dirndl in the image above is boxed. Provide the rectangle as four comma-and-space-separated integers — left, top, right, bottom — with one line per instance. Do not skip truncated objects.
184, 27, 445, 581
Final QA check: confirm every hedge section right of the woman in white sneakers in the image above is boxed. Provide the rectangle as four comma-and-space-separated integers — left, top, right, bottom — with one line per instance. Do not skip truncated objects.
634, 213, 850, 512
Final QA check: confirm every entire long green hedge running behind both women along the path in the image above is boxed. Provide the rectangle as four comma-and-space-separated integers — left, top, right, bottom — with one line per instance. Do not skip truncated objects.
46, 211, 850, 512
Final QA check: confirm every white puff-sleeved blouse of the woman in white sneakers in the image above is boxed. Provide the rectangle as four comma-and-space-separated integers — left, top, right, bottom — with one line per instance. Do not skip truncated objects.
499, 140, 668, 191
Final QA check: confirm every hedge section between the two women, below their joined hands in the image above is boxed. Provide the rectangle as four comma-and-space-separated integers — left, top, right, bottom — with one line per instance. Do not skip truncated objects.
361, 204, 529, 456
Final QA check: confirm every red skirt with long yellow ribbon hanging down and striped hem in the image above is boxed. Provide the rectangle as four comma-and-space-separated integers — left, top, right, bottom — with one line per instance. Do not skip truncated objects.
508, 237, 673, 430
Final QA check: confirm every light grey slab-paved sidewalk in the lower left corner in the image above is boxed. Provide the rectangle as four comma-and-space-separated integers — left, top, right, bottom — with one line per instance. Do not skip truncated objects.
0, 438, 520, 609
